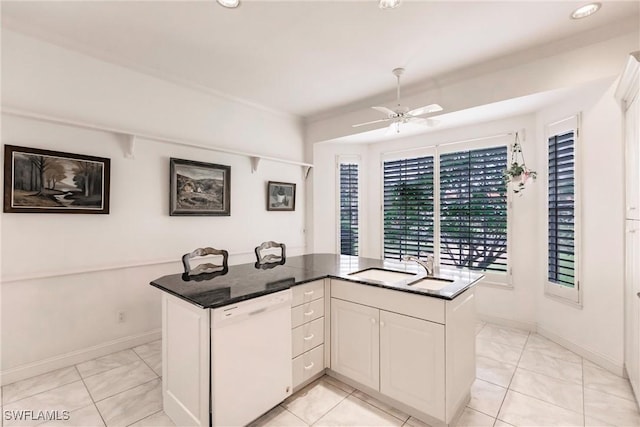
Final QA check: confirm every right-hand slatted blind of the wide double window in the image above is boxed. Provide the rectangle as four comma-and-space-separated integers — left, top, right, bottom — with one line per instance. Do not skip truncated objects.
440, 146, 507, 272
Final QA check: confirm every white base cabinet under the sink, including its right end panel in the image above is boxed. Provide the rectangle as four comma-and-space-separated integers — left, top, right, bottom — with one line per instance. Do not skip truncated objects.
331, 279, 475, 424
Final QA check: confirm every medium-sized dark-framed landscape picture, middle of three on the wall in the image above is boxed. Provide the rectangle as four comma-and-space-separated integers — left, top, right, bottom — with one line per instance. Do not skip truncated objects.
169, 158, 231, 216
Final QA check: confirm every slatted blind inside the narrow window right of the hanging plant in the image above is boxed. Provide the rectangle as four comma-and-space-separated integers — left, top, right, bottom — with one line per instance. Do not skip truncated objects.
548, 131, 575, 287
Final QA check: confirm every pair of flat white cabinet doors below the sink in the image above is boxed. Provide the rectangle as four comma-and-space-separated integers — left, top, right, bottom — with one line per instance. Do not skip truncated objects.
331, 298, 445, 418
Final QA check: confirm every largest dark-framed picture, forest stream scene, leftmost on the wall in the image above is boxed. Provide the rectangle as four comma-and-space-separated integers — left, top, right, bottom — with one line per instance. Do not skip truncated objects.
4, 145, 111, 214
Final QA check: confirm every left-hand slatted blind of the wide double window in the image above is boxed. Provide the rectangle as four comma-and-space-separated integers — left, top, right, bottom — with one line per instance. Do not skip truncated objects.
383, 156, 434, 260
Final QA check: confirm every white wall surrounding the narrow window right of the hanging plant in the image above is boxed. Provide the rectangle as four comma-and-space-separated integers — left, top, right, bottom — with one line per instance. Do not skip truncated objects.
536, 80, 624, 372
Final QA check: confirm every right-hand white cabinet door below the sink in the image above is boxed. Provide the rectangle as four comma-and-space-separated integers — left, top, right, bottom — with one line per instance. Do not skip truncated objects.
380, 311, 445, 419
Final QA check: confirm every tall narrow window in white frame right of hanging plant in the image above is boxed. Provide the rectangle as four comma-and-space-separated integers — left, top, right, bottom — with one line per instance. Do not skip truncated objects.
546, 117, 579, 302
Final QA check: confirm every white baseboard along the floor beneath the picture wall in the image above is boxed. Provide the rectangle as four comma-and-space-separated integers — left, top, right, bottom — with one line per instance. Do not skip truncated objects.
0, 329, 162, 385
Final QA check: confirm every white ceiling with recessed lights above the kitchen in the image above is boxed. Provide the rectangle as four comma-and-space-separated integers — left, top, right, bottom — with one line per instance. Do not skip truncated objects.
2, 0, 640, 117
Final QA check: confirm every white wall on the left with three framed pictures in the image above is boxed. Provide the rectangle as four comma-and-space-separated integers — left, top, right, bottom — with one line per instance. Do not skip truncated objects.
0, 30, 305, 383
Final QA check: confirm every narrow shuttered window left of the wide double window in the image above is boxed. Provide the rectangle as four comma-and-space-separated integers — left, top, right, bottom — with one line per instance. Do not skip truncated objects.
339, 163, 358, 255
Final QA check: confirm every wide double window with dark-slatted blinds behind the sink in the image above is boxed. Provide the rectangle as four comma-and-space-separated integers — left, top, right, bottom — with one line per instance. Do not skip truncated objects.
382, 139, 512, 286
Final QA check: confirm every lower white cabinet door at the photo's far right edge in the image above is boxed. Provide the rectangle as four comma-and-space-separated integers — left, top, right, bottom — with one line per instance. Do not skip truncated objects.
625, 220, 640, 403
